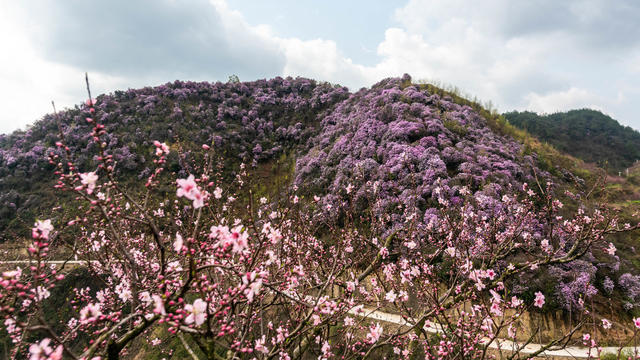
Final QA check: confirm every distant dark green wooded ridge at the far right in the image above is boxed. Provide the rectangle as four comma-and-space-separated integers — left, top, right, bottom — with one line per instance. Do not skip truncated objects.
503, 109, 640, 172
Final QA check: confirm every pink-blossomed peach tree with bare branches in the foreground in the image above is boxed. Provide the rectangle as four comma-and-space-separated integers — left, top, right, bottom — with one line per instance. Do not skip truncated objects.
0, 79, 638, 360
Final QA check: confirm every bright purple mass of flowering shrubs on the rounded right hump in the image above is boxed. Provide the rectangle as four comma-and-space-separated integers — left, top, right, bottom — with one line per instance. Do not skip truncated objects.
296, 79, 532, 238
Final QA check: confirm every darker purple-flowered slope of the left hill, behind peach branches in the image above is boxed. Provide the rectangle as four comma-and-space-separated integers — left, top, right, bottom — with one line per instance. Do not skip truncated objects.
0, 78, 347, 237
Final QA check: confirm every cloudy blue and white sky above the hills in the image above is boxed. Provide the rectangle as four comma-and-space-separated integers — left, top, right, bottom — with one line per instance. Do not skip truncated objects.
0, 0, 640, 133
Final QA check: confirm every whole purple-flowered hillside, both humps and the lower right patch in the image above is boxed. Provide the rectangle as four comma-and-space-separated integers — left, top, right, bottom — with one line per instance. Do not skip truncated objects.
0, 75, 640, 311
